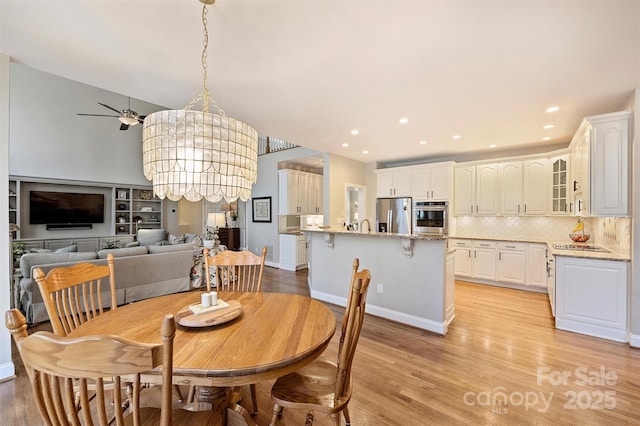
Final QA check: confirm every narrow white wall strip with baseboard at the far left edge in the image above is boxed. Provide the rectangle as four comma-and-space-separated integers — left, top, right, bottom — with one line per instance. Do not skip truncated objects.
0, 54, 15, 380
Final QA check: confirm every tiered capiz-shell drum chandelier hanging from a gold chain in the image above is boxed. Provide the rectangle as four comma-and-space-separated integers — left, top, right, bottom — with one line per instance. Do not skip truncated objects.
142, 0, 258, 202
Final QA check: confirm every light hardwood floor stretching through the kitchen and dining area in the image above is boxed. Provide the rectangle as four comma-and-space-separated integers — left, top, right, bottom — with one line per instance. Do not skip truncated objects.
0, 268, 640, 426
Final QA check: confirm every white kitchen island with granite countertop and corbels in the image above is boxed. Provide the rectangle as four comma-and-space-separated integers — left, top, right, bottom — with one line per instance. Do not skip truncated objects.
304, 228, 455, 335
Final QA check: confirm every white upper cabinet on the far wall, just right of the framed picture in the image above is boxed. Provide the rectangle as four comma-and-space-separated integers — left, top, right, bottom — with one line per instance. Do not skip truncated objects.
278, 169, 322, 214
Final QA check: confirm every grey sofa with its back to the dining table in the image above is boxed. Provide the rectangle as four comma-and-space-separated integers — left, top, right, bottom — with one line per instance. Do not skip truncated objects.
20, 244, 194, 324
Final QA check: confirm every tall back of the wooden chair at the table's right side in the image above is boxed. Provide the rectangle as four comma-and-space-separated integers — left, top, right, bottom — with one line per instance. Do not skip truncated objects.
335, 258, 371, 398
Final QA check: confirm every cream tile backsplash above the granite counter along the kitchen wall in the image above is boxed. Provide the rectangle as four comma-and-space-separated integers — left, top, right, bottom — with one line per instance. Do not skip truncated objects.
456, 216, 631, 253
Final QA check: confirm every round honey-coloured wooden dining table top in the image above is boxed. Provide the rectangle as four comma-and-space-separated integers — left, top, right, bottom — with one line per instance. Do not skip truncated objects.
69, 291, 336, 387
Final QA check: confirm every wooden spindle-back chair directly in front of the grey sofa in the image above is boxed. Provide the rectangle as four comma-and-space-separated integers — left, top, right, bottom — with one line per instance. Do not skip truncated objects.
33, 253, 118, 336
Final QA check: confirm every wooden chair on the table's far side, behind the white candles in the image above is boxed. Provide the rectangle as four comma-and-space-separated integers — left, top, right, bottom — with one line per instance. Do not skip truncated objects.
204, 247, 267, 291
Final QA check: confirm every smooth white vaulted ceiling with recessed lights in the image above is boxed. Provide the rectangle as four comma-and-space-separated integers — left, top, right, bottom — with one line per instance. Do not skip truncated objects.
0, 0, 640, 162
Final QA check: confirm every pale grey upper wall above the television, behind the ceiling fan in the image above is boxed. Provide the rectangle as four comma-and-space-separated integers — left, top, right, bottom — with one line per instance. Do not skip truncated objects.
9, 63, 164, 185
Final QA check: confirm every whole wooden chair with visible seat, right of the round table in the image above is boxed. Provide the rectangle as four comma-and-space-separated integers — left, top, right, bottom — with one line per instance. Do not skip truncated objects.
270, 258, 371, 425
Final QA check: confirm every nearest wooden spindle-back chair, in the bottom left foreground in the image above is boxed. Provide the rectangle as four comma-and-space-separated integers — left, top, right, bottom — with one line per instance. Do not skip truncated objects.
5, 309, 222, 426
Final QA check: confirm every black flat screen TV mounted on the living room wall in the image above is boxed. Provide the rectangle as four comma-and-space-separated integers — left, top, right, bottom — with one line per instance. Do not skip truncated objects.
29, 191, 104, 225
